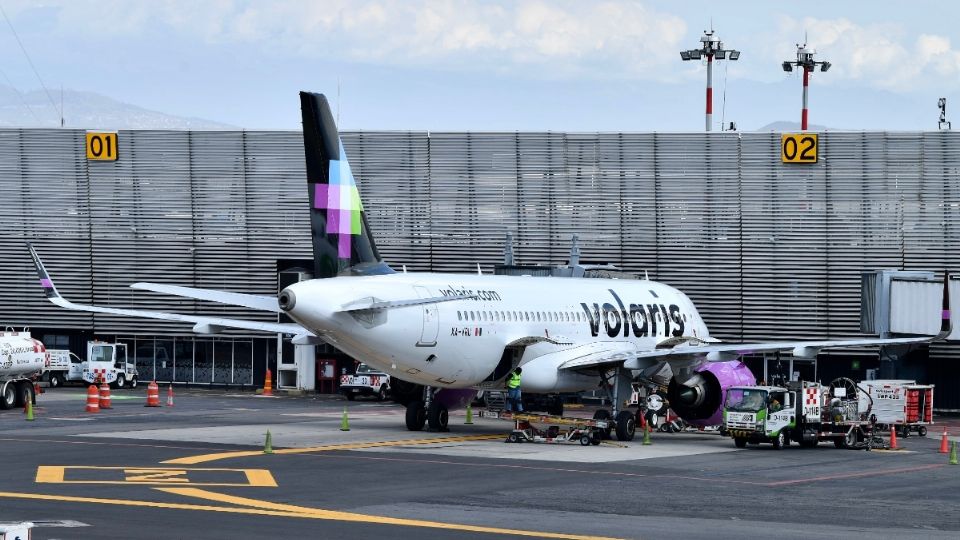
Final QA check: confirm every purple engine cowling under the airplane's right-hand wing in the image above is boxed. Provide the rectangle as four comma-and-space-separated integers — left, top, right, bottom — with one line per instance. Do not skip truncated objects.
667, 360, 757, 426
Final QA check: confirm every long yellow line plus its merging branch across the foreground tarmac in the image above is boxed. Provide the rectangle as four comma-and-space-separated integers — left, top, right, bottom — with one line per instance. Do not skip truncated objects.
0, 488, 614, 540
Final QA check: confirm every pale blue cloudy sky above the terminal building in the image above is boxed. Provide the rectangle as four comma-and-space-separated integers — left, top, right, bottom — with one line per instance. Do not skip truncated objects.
0, 0, 960, 131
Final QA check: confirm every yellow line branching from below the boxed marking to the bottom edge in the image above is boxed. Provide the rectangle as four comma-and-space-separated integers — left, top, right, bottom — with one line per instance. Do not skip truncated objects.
157, 488, 624, 540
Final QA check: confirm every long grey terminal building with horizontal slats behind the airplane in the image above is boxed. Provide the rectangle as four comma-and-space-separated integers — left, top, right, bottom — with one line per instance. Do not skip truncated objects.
0, 129, 960, 410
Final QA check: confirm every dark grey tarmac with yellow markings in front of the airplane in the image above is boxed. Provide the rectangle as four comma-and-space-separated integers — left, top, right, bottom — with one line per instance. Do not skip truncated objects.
0, 386, 960, 540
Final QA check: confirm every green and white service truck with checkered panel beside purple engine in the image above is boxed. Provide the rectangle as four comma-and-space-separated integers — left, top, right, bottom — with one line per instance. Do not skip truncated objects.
721, 379, 872, 449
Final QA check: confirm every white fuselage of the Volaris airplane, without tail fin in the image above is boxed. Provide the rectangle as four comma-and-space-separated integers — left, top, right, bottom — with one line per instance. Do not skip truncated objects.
286, 273, 709, 392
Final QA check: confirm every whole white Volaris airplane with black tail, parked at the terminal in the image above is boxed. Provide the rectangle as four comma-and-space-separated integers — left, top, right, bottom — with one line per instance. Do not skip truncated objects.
29, 92, 950, 440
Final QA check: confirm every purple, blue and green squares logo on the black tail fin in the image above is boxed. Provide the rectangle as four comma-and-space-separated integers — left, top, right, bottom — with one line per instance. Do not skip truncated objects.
313, 144, 363, 259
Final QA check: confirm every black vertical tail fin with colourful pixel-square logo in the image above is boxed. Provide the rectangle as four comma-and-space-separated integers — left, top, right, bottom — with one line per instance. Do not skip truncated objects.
300, 92, 393, 278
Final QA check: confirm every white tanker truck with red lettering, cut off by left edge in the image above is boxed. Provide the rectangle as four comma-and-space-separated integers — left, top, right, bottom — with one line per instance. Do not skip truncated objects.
0, 327, 47, 409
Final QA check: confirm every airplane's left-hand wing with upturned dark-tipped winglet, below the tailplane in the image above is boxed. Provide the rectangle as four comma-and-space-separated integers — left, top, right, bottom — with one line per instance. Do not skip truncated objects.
27, 244, 316, 337
